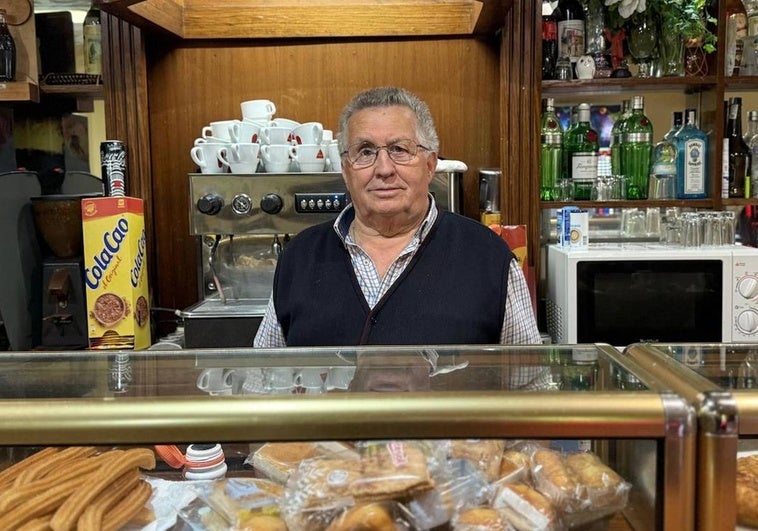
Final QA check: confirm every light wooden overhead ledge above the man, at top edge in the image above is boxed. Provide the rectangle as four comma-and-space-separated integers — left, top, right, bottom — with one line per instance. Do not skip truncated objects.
100, 0, 513, 39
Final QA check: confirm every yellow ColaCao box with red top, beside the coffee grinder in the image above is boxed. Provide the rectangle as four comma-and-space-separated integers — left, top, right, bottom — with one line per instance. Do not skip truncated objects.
82, 197, 150, 349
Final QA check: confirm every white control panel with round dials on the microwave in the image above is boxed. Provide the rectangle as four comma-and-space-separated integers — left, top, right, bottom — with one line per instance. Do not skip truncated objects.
730, 252, 758, 342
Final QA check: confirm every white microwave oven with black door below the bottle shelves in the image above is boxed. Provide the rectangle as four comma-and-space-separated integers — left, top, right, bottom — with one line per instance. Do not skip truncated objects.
546, 243, 758, 347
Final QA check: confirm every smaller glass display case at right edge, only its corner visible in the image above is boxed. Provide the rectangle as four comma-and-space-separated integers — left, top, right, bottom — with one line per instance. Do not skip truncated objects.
624, 343, 758, 530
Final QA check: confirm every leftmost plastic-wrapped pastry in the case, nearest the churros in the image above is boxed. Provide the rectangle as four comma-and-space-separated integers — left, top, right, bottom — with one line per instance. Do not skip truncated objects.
195, 477, 284, 529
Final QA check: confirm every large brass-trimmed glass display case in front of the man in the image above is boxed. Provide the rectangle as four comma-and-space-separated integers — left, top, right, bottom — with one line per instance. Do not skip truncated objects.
0, 344, 696, 530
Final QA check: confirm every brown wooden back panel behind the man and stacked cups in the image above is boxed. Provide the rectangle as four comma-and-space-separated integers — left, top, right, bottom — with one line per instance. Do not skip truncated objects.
148, 37, 501, 314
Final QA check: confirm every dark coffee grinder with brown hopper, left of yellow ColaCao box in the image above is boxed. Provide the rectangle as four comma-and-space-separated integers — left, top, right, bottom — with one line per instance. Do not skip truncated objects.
31, 194, 96, 349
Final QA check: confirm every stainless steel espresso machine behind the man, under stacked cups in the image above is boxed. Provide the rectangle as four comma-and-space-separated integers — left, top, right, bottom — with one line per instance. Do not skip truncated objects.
183, 172, 462, 348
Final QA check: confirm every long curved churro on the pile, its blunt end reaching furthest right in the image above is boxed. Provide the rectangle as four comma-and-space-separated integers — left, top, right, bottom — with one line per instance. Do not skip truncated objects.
50, 448, 155, 531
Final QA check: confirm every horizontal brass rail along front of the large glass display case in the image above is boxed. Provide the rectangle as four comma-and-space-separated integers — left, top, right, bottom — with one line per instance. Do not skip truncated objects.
0, 392, 666, 445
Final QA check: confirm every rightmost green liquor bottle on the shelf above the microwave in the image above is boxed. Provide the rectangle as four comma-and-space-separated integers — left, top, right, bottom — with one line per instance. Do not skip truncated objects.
621, 96, 653, 199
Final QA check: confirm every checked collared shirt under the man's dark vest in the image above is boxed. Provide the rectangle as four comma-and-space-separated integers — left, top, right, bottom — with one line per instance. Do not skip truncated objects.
253, 195, 541, 348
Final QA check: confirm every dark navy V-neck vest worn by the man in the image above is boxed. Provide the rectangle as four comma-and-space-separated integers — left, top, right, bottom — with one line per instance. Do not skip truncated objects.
274, 210, 514, 346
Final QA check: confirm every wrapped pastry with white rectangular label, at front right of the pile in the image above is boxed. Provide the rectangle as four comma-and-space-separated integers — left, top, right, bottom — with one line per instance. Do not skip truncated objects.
492, 483, 563, 531
